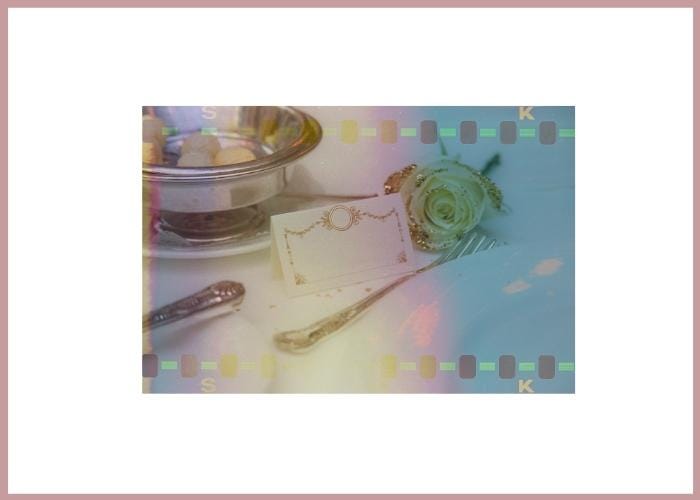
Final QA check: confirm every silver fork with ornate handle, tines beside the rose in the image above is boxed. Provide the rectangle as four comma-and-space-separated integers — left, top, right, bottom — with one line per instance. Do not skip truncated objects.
274, 230, 498, 353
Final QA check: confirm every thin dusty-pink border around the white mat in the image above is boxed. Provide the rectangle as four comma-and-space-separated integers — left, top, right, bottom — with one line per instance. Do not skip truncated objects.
0, 0, 700, 500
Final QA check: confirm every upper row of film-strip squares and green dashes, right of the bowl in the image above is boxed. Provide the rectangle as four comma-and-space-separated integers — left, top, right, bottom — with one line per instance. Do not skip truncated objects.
323, 120, 575, 145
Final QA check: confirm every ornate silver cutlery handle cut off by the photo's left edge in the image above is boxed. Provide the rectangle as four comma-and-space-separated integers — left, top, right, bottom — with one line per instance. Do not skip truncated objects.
143, 281, 245, 332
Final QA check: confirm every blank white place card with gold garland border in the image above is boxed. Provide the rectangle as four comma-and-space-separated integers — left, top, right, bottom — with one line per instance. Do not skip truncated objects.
271, 194, 415, 296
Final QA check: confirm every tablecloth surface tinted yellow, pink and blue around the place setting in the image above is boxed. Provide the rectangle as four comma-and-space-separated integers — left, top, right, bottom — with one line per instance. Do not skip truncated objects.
143, 107, 574, 393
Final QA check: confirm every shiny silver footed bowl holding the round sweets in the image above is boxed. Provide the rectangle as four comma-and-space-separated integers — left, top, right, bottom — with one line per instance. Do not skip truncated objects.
142, 106, 321, 241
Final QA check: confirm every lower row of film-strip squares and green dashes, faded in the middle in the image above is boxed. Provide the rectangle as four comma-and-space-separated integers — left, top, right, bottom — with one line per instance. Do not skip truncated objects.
142, 354, 574, 380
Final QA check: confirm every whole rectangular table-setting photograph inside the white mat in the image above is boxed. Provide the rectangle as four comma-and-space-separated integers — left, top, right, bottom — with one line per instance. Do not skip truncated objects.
141, 106, 575, 394
